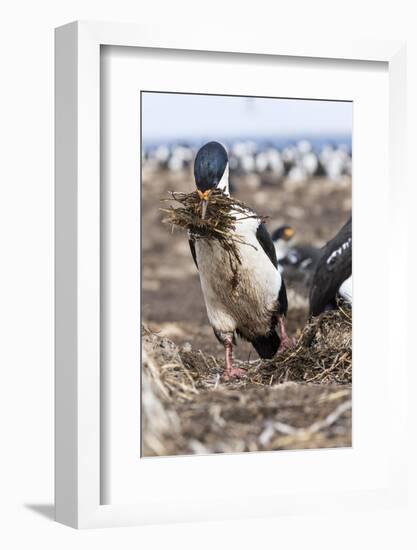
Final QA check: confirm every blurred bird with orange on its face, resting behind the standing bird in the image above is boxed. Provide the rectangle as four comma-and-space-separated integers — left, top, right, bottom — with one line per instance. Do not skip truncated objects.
271, 225, 321, 273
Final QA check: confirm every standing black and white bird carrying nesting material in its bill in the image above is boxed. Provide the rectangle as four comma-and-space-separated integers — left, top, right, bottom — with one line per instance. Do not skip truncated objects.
189, 141, 291, 379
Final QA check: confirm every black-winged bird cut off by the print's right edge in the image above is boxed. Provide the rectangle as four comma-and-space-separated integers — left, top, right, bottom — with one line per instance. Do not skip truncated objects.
310, 218, 352, 315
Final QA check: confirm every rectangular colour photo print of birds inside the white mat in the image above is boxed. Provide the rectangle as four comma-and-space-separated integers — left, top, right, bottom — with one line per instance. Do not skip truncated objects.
138, 91, 352, 457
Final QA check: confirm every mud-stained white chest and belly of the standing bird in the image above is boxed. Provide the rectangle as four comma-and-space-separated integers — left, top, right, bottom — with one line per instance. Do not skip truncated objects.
195, 219, 281, 337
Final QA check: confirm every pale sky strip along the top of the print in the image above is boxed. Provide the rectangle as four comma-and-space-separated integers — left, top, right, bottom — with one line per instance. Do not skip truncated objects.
142, 92, 352, 143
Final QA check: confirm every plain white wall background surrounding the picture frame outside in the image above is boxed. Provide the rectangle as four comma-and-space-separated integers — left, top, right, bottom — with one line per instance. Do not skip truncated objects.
0, 0, 417, 550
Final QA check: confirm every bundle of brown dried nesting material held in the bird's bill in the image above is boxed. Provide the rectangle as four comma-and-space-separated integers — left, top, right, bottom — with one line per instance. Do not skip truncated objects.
161, 189, 264, 264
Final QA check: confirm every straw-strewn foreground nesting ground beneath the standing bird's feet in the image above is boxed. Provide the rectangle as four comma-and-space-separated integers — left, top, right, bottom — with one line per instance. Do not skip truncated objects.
142, 310, 352, 456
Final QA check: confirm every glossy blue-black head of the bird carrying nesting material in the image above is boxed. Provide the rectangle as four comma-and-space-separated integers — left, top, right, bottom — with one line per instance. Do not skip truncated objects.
194, 141, 228, 193
